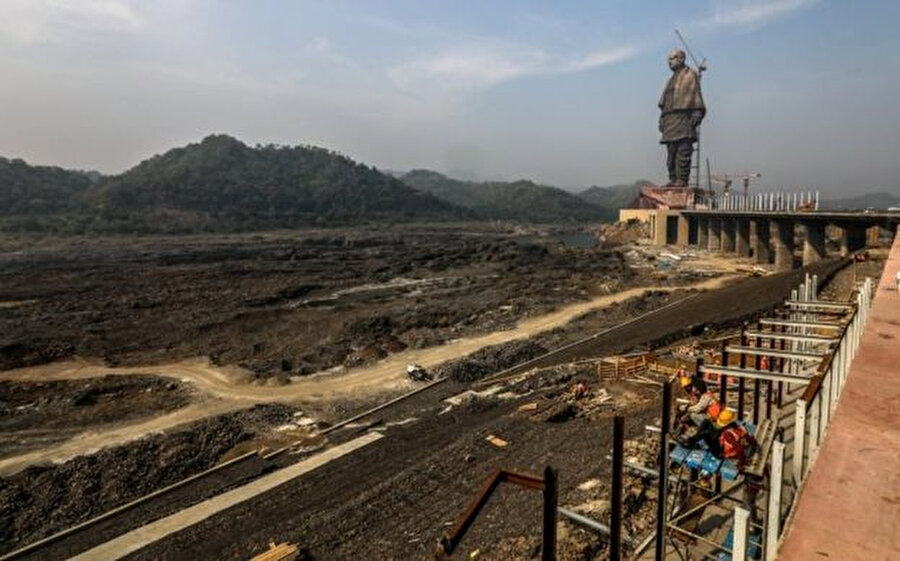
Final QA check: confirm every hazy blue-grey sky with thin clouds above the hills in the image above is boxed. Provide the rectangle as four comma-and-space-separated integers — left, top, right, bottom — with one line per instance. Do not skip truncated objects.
0, 0, 900, 194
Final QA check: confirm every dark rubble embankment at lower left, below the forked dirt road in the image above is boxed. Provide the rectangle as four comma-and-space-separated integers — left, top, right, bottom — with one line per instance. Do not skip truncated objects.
0, 405, 293, 551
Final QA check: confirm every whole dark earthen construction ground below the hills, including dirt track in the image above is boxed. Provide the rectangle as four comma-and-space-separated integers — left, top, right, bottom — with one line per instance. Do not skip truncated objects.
0, 212, 896, 560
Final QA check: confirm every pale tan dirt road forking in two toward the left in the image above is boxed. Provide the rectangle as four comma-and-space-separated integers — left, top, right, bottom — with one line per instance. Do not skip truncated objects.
0, 276, 735, 475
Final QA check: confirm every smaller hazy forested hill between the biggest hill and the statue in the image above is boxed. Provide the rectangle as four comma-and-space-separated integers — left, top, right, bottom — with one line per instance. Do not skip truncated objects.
400, 169, 611, 222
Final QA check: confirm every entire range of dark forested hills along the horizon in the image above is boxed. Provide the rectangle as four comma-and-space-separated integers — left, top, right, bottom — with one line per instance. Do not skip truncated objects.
0, 135, 900, 234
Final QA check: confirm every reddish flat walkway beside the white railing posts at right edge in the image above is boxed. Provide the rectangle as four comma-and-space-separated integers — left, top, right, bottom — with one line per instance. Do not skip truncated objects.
778, 230, 900, 561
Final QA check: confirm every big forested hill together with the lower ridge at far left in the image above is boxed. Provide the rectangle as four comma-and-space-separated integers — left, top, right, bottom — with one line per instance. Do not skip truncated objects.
0, 135, 471, 234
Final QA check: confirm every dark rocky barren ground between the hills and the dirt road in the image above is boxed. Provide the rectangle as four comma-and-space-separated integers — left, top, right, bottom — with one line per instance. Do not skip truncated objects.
0, 225, 636, 377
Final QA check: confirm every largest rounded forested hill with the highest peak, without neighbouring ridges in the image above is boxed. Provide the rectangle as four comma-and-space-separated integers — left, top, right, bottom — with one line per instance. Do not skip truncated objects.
88, 135, 465, 231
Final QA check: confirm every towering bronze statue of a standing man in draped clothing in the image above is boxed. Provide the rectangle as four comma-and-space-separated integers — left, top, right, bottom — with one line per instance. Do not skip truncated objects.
659, 50, 706, 186
